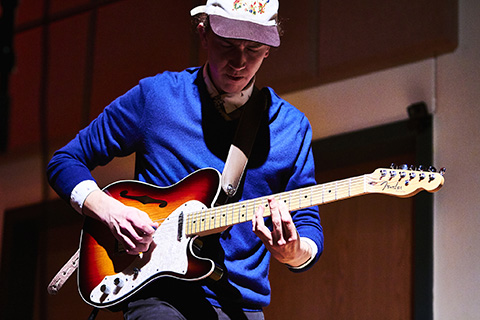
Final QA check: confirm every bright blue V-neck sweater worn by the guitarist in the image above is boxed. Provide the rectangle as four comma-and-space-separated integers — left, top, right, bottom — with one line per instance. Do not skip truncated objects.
47, 68, 323, 310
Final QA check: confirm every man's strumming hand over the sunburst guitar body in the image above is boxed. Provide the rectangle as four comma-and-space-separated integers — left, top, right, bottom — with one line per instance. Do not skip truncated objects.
83, 190, 159, 255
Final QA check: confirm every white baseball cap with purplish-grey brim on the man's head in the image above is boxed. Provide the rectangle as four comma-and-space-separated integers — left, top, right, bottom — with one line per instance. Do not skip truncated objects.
190, 0, 280, 47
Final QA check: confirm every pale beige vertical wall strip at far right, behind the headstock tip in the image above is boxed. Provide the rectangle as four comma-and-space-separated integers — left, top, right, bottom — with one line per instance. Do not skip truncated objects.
434, 0, 480, 319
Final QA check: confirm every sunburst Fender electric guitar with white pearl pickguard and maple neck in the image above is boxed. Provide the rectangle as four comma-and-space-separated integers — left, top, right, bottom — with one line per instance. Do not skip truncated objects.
78, 168, 444, 308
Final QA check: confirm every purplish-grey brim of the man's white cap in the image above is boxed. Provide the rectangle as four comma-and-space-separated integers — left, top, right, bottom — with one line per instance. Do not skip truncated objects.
209, 15, 280, 47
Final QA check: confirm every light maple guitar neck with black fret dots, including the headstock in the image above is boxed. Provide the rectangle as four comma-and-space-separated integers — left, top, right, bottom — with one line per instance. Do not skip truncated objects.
185, 168, 445, 235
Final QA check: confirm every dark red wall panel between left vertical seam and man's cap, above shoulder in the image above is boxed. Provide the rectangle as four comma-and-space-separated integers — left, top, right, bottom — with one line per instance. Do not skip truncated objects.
91, 0, 191, 118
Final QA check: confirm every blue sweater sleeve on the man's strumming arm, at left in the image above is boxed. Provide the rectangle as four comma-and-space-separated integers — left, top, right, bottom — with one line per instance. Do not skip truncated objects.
47, 85, 144, 201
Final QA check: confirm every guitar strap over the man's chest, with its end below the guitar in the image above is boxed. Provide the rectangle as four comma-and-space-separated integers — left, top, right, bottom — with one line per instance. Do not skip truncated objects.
47, 87, 271, 295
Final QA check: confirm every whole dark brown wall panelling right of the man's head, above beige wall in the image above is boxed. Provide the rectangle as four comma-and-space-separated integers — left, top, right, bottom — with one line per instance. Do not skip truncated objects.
259, 0, 458, 92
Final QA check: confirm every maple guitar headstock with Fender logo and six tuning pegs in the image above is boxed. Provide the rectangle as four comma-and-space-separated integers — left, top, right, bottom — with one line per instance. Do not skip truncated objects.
366, 165, 445, 198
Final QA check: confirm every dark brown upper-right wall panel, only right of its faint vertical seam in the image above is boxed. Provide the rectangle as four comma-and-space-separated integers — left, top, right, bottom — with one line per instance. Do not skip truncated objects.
318, 0, 458, 83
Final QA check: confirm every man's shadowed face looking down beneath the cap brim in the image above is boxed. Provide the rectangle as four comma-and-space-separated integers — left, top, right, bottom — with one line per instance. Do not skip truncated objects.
199, 26, 270, 93
